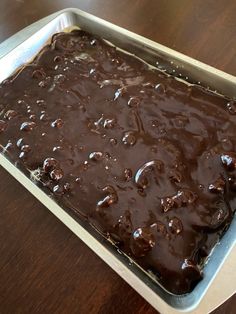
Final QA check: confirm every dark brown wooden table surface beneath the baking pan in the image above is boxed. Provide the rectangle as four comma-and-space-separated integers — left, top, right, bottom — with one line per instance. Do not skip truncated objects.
0, 0, 236, 314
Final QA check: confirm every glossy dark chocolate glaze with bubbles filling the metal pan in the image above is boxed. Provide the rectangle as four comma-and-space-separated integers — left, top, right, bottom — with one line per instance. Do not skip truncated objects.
0, 31, 236, 294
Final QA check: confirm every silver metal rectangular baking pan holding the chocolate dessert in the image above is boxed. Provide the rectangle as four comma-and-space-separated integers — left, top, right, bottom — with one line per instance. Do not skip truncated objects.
0, 9, 236, 313
